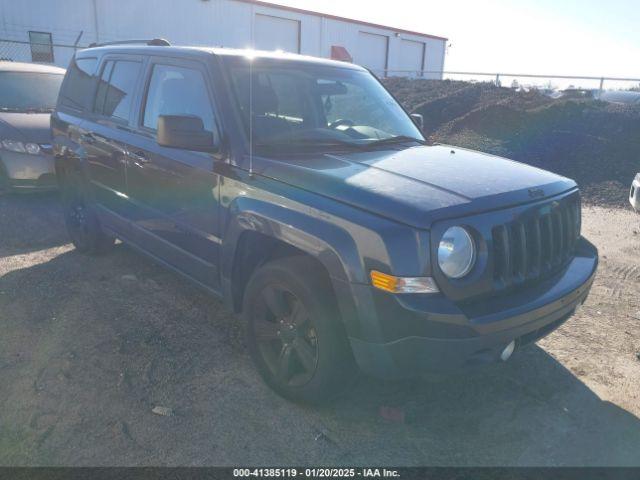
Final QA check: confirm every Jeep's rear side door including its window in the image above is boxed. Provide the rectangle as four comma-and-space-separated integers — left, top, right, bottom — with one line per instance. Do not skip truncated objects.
80, 55, 143, 227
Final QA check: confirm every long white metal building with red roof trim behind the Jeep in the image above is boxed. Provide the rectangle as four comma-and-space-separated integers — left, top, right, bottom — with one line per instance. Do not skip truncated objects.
0, 0, 447, 78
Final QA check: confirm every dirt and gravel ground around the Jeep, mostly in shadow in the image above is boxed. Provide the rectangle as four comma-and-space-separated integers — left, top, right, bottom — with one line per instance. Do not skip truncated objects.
0, 196, 640, 466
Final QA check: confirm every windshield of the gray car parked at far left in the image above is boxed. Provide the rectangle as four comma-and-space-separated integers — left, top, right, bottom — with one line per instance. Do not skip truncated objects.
0, 72, 64, 112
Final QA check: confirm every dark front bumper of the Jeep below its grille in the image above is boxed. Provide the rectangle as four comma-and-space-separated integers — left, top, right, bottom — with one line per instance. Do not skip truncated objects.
350, 239, 598, 378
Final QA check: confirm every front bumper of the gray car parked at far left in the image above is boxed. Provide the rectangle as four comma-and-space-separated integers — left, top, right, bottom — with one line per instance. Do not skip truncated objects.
0, 151, 57, 191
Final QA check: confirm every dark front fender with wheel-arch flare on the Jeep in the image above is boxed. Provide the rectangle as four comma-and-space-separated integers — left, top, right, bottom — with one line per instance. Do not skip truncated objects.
220, 170, 430, 338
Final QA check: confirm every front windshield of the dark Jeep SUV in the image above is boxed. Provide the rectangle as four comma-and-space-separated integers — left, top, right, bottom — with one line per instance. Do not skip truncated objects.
226, 58, 424, 150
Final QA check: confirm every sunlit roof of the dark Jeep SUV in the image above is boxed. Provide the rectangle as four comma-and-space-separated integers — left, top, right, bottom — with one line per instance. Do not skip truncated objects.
82, 44, 362, 70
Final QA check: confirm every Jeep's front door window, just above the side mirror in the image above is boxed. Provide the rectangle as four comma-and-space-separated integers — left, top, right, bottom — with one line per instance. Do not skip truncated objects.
142, 65, 214, 132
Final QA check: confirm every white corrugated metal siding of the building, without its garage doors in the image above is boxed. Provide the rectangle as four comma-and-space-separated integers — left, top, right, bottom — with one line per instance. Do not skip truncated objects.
0, 0, 445, 78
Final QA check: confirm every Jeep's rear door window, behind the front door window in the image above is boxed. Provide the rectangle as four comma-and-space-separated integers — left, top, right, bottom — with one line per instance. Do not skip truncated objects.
93, 60, 141, 120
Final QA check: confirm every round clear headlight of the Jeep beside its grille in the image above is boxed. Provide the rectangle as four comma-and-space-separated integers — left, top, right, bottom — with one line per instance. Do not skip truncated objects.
438, 227, 476, 278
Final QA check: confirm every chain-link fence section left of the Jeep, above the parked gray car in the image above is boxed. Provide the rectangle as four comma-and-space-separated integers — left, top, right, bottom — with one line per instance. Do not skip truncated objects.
0, 39, 82, 68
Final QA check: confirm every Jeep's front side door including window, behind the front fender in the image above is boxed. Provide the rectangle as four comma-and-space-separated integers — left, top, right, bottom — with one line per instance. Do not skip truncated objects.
127, 58, 220, 289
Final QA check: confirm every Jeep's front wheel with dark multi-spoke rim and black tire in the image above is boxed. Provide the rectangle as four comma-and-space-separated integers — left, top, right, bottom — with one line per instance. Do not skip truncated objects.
243, 256, 356, 404
